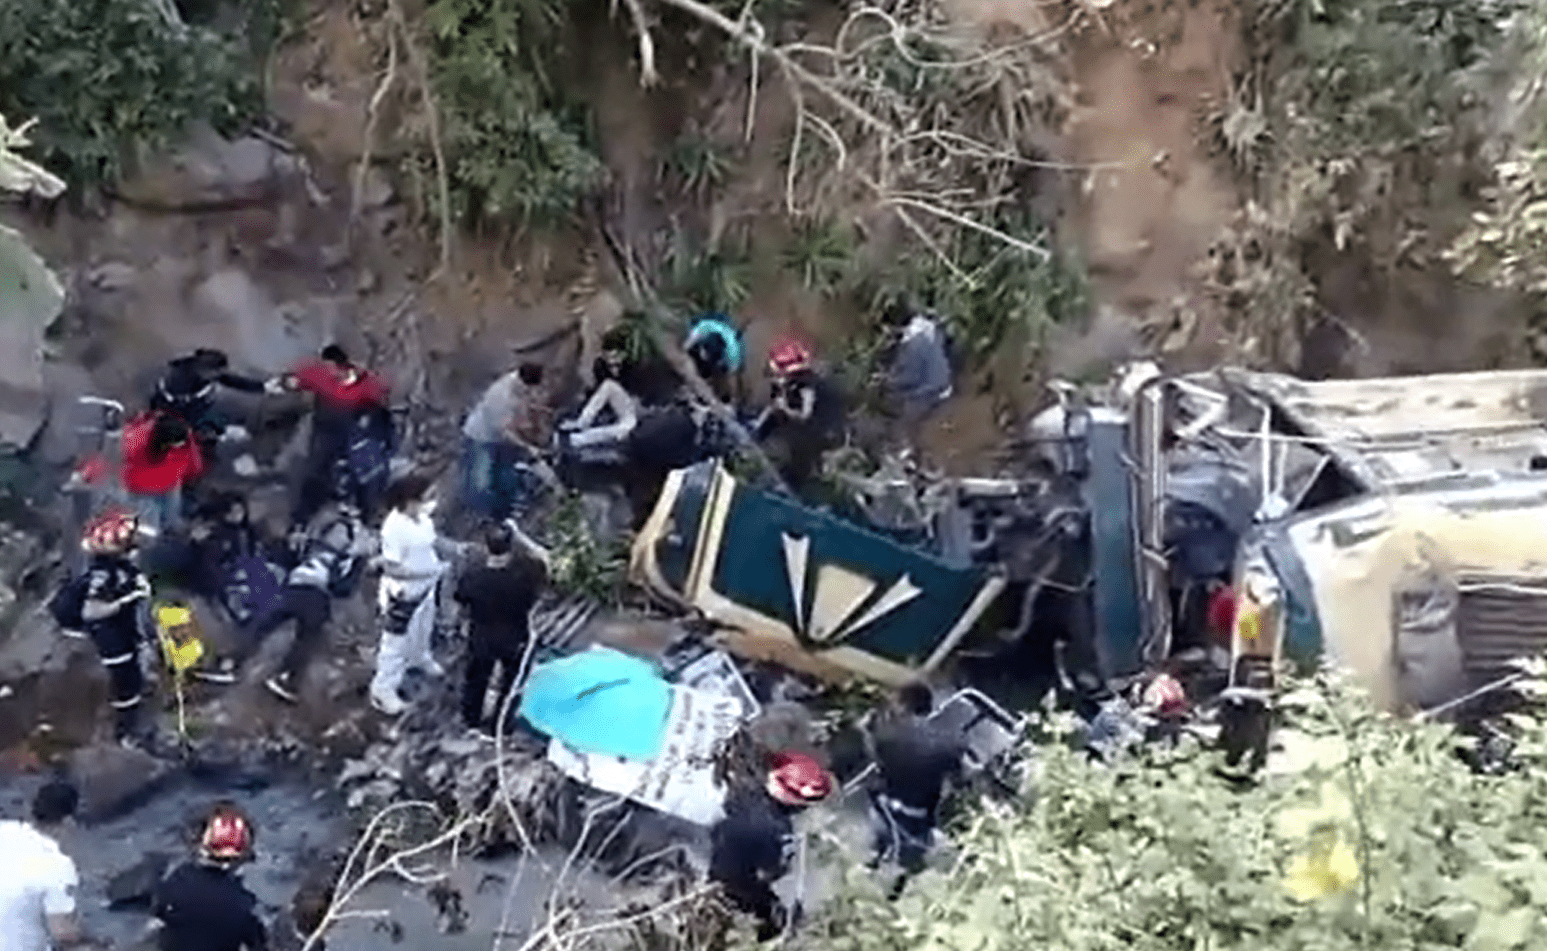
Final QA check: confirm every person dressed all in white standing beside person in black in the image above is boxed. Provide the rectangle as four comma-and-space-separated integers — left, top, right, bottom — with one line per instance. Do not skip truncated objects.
370, 473, 446, 716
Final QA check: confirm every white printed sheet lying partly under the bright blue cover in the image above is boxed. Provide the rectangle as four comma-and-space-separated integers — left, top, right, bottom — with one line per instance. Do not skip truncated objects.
548, 685, 747, 826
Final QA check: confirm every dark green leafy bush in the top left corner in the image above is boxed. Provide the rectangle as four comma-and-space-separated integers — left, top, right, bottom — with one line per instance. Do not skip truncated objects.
0, 0, 269, 186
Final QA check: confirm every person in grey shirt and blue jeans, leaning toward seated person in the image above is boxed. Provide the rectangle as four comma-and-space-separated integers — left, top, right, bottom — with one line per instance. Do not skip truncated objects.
463, 363, 552, 518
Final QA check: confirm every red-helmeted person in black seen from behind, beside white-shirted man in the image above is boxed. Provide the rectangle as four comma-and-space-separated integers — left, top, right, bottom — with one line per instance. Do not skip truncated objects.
150, 803, 269, 951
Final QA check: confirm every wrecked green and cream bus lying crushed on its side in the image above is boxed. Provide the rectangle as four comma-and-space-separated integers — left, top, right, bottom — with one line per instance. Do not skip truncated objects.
631, 363, 1547, 736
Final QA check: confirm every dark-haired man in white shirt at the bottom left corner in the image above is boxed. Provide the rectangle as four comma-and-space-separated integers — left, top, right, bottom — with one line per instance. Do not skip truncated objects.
0, 781, 102, 951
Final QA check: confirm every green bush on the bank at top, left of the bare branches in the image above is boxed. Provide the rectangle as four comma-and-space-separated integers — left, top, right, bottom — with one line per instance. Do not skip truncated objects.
424, 0, 605, 224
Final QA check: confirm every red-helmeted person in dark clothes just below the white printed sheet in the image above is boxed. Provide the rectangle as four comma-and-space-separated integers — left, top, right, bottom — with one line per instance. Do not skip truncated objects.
709, 752, 834, 942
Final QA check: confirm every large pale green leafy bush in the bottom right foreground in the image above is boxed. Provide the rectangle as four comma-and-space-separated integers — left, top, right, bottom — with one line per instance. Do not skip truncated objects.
773, 670, 1547, 951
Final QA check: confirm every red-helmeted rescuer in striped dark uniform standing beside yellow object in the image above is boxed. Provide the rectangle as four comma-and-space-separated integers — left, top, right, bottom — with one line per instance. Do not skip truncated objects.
80, 512, 150, 745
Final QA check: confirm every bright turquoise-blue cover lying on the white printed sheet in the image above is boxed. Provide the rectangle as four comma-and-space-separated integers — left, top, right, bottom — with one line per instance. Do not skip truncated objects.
521, 648, 671, 759
